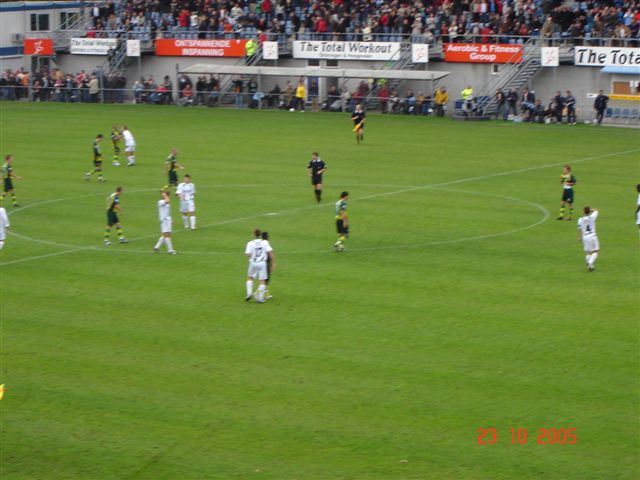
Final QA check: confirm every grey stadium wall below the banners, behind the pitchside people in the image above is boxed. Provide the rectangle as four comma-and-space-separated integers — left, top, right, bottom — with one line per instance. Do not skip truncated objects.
51, 54, 638, 116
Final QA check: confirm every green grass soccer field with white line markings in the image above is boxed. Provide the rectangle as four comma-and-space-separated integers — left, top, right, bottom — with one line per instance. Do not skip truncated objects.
0, 103, 640, 480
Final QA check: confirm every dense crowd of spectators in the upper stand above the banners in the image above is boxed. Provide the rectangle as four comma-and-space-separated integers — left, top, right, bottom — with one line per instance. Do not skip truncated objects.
87, 0, 640, 43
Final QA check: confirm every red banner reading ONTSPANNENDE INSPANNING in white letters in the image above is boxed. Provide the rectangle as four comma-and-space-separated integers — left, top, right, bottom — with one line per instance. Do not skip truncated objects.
156, 38, 247, 57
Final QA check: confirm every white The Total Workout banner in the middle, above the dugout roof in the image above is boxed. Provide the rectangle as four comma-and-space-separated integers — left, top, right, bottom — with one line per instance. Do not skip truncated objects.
293, 40, 401, 60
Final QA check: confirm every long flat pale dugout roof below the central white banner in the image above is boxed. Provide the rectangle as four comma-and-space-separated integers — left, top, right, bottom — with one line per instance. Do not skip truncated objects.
180, 63, 449, 80
